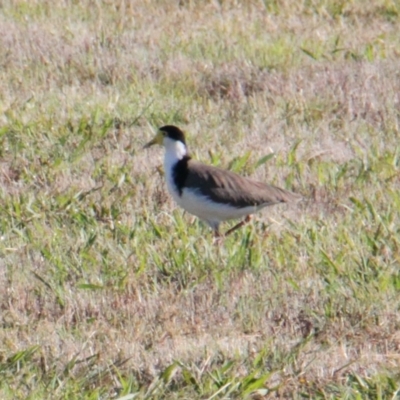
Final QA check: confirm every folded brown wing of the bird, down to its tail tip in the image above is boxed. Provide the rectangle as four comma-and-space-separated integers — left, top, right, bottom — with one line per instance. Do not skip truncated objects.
184, 160, 300, 208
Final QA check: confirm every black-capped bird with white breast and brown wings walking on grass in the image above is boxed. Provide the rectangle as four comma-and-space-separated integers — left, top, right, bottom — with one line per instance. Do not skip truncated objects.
144, 125, 301, 238
